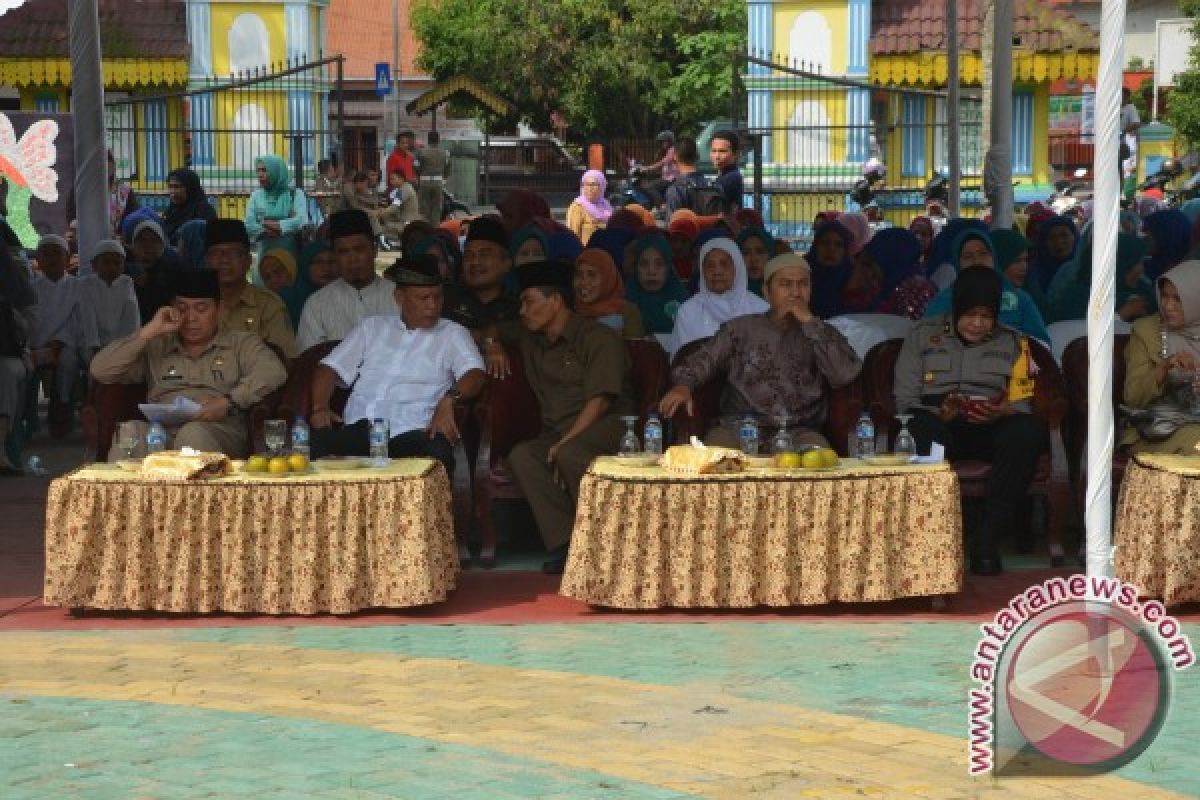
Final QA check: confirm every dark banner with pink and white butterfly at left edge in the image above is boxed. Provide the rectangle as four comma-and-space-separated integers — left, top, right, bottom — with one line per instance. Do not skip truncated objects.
0, 112, 74, 248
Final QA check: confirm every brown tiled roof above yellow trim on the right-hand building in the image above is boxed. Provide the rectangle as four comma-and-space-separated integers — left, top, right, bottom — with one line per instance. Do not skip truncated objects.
871, 0, 1099, 55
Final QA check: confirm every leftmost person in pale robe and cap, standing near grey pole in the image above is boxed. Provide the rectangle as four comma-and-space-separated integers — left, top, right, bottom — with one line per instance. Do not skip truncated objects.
29, 234, 83, 438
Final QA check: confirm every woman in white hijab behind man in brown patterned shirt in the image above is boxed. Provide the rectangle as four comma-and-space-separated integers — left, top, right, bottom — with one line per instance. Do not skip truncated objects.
667, 236, 769, 357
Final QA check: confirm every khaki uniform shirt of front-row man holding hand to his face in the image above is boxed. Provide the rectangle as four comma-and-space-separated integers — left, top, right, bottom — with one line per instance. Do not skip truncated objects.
91, 331, 288, 409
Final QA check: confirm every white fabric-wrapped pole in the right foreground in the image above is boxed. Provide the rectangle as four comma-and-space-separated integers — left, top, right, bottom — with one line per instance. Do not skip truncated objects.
1084, 0, 1124, 576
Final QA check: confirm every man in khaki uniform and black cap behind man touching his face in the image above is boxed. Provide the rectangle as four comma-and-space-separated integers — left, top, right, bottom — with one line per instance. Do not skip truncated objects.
204, 219, 298, 360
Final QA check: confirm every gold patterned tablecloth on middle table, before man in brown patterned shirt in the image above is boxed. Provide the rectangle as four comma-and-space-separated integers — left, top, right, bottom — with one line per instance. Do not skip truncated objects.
559, 459, 962, 608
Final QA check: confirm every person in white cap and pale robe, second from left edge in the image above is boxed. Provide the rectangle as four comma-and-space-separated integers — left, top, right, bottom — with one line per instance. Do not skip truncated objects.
79, 239, 142, 361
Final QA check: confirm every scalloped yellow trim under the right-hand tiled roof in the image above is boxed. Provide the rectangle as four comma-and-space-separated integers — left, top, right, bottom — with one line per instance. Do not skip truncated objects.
871, 52, 1099, 88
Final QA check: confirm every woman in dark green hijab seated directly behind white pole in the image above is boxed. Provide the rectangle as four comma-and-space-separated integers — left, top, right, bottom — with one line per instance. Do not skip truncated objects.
1048, 223, 1158, 323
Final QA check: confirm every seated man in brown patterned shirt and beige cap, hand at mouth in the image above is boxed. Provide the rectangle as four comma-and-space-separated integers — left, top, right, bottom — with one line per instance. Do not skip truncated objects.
660, 253, 863, 447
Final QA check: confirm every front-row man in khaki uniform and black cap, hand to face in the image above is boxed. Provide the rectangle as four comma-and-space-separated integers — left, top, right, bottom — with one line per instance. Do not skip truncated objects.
91, 270, 288, 459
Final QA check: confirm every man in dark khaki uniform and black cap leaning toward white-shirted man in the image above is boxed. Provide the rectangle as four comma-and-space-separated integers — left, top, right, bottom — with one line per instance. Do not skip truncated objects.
488, 261, 634, 575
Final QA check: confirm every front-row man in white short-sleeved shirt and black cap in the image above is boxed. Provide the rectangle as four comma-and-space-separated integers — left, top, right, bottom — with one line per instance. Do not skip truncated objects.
311, 254, 484, 476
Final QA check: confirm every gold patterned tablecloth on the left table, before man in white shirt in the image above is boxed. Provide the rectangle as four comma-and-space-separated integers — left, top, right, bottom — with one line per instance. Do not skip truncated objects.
44, 458, 458, 614
